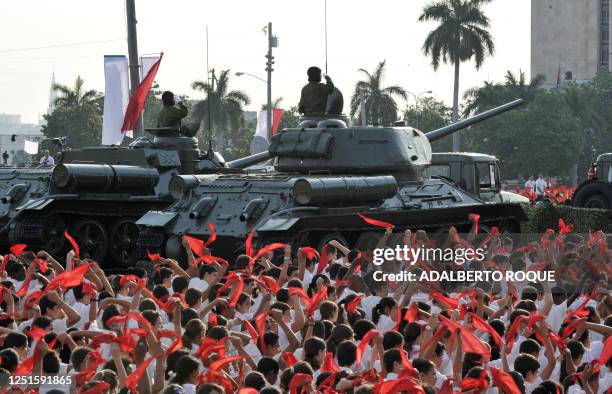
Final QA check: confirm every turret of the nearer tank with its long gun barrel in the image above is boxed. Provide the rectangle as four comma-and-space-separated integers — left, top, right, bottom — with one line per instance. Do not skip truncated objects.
262, 100, 523, 179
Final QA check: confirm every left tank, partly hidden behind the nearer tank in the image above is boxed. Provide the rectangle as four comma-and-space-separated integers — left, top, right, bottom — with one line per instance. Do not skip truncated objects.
0, 128, 256, 266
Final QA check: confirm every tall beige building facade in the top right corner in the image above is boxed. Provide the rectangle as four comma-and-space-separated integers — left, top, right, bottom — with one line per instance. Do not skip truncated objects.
531, 0, 610, 87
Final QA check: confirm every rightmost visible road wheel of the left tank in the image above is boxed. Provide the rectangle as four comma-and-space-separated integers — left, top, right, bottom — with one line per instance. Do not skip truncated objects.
108, 219, 140, 267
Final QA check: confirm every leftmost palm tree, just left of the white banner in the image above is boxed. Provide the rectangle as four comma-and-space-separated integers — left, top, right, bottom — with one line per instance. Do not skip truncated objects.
42, 76, 103, 148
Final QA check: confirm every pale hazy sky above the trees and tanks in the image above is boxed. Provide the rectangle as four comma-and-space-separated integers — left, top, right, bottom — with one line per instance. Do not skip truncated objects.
0, 0, 530, 122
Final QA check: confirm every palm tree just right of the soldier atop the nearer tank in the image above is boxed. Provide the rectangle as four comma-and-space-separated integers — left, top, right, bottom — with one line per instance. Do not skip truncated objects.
351, 60, 407, 126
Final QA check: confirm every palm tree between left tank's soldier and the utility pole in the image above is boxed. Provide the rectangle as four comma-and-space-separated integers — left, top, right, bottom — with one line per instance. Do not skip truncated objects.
191, 70, 251, 150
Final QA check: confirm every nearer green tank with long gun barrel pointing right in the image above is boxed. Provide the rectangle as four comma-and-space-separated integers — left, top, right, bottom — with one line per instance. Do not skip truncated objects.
137, 100, 526, 258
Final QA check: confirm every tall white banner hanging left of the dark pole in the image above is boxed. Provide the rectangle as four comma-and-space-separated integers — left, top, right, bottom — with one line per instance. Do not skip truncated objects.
102, 55, 131, 145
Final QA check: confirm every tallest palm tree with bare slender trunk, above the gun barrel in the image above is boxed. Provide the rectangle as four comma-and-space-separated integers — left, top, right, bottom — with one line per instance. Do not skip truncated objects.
419, 0, 495, 152
